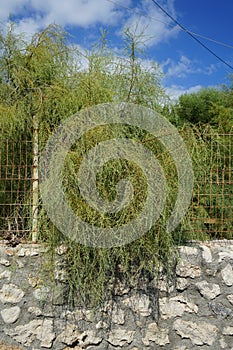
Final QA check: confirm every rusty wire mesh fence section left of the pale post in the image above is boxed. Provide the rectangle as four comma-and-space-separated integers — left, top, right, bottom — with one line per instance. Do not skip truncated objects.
0, 139, 32, 239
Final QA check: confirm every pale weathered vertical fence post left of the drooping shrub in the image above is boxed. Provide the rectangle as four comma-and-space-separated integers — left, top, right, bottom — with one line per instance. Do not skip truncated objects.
32, 115, 39, 242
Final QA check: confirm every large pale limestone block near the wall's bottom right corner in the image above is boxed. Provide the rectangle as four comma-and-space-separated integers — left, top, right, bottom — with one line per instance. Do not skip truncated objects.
173, 319, 218, 345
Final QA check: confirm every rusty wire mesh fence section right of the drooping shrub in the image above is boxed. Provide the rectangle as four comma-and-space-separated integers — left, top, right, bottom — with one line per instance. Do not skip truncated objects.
187, 130, 233, 239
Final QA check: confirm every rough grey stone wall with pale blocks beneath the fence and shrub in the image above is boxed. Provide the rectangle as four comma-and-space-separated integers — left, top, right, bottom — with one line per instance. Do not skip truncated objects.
0, 242, 233, 350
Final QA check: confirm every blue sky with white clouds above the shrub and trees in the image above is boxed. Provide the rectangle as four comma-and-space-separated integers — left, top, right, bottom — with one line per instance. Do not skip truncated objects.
0, 0, 233, 98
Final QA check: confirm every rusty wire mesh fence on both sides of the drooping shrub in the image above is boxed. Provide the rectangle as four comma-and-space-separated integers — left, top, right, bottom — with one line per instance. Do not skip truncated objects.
0, 126, 233, 242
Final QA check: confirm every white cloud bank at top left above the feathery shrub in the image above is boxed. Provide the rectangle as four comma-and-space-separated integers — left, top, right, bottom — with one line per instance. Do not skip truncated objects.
0, 0, 130, 34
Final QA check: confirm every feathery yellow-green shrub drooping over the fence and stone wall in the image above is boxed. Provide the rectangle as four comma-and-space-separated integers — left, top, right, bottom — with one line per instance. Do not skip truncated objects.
0, 25, 175, 305
